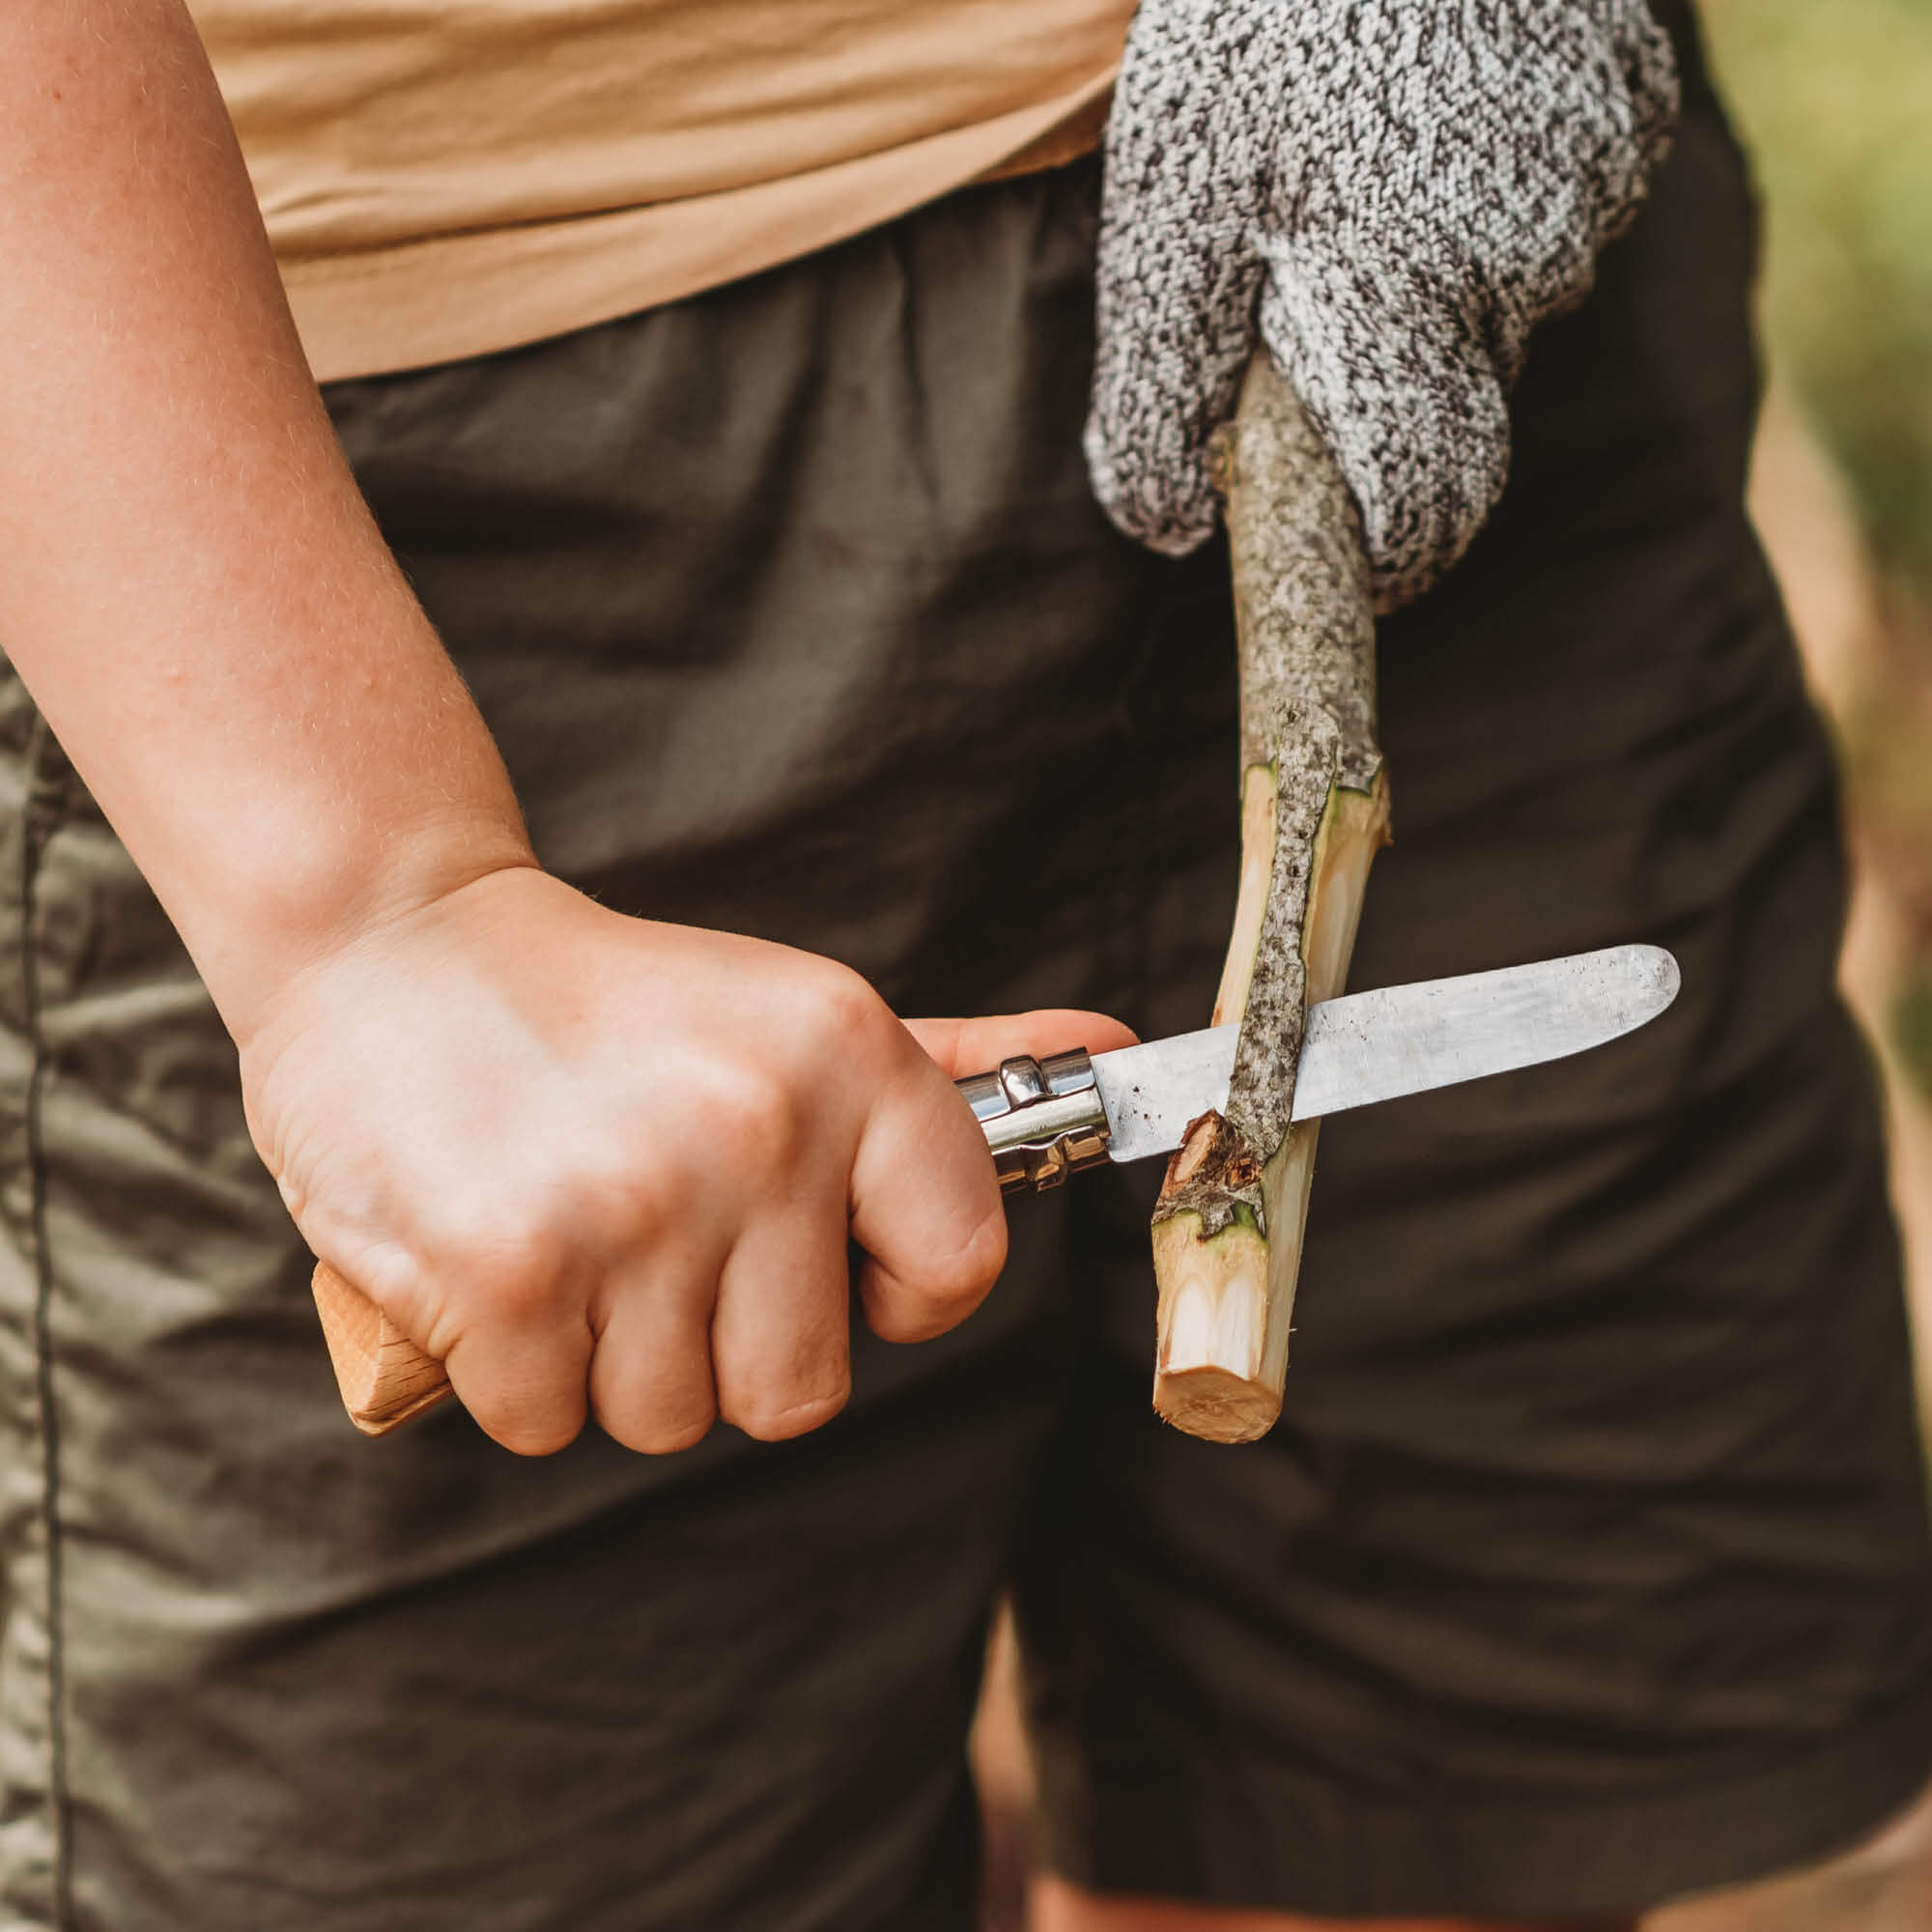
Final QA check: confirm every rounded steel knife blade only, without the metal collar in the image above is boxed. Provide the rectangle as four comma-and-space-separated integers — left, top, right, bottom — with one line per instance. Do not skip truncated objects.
1094, 947, 1677, 1161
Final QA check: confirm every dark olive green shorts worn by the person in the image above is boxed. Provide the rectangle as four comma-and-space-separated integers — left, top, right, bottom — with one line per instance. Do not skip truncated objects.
0, 7, 1932, 1932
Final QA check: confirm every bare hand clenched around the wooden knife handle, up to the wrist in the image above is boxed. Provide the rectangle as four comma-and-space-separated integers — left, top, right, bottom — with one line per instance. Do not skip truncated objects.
242, 867, 1132, 1453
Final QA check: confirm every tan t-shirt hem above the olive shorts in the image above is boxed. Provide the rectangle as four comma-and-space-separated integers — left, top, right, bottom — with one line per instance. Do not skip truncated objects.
191, 0, 1132, 381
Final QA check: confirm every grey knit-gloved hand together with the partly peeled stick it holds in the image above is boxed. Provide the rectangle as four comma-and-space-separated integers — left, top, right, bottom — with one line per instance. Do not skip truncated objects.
1086, 0, 1677, 1441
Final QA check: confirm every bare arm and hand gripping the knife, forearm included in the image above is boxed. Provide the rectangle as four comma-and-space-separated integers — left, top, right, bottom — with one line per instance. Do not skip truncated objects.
0, 0, 1130, 1453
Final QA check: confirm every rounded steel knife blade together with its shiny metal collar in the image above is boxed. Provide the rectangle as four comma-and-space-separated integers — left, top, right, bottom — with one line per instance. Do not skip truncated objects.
958, 945, 1679, 1188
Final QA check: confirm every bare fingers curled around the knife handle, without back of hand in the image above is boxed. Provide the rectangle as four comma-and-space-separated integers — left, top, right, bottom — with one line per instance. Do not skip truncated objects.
415, 1009, 1134, 1455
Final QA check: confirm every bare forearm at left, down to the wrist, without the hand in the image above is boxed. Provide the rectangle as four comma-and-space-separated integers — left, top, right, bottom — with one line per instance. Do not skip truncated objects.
0, 0, 529, 1032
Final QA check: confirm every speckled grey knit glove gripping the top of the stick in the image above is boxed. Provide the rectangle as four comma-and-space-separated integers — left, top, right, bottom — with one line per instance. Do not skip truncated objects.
1086, 0, 1677, 611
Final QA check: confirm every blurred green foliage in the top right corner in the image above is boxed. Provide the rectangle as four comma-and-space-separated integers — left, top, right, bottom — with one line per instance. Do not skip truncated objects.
1704, 0, 1932, 601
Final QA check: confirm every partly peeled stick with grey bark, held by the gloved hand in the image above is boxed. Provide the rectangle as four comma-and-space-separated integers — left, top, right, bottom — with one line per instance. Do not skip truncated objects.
1153, 355, 1389, 1441
